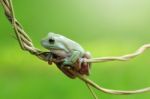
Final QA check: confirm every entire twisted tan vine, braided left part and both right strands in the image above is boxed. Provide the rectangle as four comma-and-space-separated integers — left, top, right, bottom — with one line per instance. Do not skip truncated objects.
0, 0, 150, 99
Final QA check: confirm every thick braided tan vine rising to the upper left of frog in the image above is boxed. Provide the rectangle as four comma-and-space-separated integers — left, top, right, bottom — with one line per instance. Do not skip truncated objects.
0, 0, 47, 61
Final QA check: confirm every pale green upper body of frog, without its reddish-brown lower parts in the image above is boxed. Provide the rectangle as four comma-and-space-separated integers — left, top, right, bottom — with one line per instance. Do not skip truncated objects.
41, 32, 85, 66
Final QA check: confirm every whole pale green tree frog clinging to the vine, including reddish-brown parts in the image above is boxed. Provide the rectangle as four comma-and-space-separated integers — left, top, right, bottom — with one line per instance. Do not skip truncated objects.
41, 32, 91, 78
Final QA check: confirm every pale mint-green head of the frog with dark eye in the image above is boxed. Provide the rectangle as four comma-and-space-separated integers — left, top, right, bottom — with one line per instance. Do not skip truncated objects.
41, 32, 65, 50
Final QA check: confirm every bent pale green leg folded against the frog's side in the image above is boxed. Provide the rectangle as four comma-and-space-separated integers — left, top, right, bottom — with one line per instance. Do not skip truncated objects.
63, 51, 81, 66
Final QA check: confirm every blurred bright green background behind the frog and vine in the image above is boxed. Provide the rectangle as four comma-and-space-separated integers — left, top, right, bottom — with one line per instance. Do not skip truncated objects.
0, 0, 150, 99
